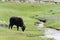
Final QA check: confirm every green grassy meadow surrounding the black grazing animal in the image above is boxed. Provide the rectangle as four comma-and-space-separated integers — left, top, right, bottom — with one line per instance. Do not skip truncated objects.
0, 3, 60, 40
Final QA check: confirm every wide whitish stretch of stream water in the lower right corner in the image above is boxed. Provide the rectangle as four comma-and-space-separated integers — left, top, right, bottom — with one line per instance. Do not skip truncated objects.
40, 28, 60, 40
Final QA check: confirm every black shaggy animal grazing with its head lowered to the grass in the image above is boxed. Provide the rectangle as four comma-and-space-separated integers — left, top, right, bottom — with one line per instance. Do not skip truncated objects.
9, 17, 25, 31
